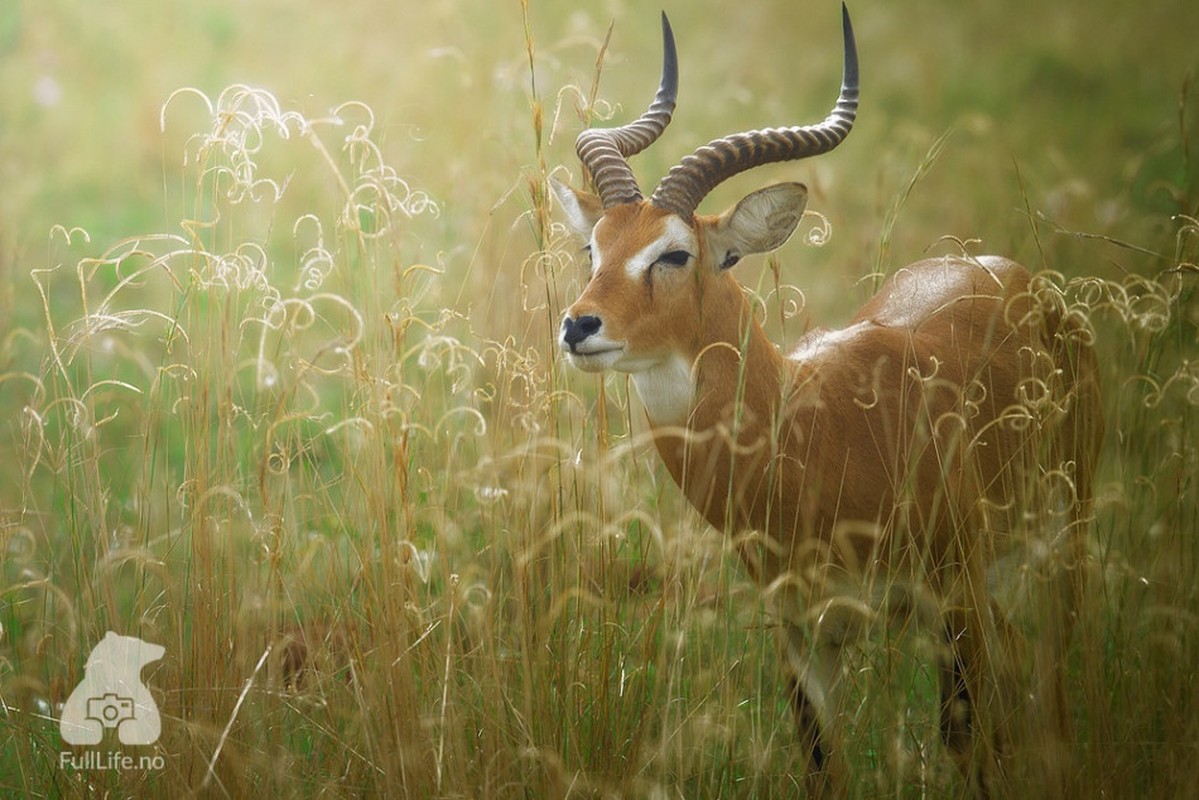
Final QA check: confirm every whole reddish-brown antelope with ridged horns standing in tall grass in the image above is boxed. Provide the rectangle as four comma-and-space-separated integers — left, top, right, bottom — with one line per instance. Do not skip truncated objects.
554, 7, 1102, 795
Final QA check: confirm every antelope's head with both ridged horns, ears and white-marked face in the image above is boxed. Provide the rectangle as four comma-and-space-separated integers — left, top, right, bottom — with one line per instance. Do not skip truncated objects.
553, 6, 858, 423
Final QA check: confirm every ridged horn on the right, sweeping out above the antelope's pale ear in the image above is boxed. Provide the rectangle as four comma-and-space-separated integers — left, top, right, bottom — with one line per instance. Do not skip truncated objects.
650, 4, 858, 219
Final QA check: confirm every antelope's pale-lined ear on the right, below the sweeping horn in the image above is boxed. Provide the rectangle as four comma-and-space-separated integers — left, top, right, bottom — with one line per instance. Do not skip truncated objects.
707, 184, 808, 270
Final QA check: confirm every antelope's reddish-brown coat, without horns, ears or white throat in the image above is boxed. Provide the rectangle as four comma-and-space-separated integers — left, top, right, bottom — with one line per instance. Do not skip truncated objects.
567, 195, 1102, 794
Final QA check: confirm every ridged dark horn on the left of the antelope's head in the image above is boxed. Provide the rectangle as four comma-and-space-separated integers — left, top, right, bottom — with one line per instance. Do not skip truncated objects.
574, 12, 679, 209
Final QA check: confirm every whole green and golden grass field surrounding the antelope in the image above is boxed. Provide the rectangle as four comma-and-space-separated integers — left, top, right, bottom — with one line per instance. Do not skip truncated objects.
0, 0, 1199, 798
